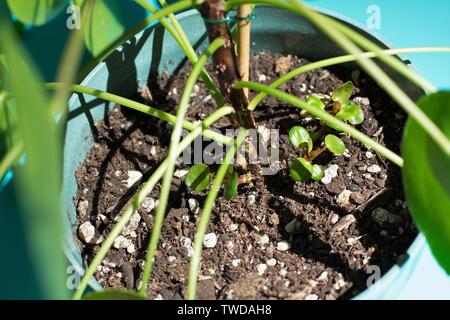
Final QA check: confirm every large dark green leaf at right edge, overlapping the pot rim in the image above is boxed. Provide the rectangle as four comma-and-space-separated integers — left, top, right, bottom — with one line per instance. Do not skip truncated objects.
402, 92, 450, 274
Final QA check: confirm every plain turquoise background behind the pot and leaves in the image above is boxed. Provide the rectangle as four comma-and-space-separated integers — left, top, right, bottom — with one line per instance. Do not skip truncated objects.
0, 0, 450, 299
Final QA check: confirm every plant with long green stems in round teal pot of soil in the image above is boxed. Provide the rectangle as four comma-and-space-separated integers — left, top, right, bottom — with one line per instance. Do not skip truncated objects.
0, 0, 449, 299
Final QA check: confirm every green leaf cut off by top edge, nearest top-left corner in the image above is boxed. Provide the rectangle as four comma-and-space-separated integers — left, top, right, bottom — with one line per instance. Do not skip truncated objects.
7, 0, 68, 26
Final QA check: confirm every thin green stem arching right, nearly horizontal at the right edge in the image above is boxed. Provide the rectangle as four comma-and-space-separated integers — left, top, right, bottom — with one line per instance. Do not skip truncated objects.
248, 47, 450, 110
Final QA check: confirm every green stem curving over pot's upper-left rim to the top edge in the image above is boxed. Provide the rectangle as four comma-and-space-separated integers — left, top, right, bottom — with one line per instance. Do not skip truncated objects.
78, 0, 192, 79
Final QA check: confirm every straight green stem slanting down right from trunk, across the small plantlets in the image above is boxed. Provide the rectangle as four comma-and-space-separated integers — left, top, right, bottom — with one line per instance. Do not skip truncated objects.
236, 81, 403, 167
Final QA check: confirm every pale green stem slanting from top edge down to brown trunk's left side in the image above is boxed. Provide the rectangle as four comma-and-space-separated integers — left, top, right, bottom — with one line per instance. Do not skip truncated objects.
134, 0, 225, 107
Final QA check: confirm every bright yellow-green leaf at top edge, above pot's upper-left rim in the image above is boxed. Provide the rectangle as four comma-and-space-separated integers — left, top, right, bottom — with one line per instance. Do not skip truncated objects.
81, 0, 125, 57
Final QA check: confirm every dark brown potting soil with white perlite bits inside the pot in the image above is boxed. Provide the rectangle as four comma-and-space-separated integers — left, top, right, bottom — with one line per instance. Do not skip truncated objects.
75, 52, 417, 299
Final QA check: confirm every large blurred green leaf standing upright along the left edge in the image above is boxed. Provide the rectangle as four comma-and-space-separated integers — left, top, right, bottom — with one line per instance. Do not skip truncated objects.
0, 14, 67, 299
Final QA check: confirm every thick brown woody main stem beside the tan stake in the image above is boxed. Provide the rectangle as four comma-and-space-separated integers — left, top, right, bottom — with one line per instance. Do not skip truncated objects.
201, 0, 256, 129
